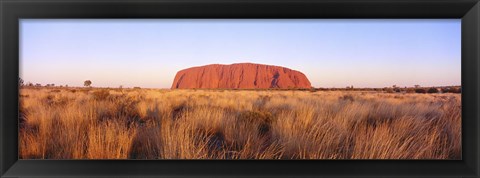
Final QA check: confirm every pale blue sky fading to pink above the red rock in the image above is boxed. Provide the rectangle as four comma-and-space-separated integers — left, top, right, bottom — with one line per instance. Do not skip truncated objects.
20, 19, 461, 88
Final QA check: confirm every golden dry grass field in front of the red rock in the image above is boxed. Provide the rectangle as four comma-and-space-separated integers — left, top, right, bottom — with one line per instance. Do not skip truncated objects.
19, 87, 461, 159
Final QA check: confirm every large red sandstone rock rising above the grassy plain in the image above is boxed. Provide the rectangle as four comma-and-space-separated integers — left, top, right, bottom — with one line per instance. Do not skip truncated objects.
172, 63, 312, 89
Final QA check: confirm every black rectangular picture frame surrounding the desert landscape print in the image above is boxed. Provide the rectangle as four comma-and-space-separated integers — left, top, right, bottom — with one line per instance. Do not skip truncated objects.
0, 0, 480, 177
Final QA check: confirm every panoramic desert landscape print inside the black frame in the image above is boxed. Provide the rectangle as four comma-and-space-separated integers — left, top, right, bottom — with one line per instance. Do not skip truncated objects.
18, 19, 462, 160
